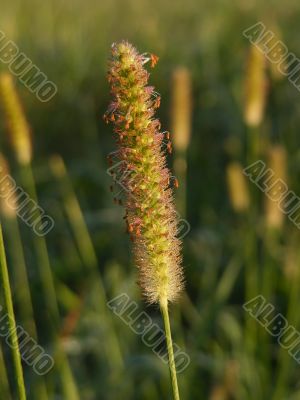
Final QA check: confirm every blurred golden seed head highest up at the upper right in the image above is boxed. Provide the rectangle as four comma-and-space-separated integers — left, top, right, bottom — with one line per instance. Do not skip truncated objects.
244, 45, 267, 127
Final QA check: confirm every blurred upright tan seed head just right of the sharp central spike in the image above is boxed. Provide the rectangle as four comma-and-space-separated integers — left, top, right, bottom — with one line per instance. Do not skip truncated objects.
171, 67, 192, 152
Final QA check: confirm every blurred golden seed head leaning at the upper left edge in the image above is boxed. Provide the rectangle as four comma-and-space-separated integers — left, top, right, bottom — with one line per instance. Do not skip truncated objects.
0, 73, 32, 165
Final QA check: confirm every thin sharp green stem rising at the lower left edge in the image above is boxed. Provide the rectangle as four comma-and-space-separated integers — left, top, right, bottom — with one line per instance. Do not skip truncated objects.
0, 224, 26, 400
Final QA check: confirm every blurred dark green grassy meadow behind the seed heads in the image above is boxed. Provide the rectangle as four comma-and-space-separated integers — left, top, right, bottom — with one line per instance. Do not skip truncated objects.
0, 0, 300, 400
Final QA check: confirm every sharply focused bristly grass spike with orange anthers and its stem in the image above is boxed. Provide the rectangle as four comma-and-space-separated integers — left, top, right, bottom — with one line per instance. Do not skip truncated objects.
105, 42, 183, 399
